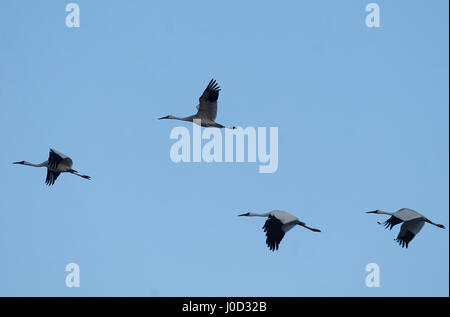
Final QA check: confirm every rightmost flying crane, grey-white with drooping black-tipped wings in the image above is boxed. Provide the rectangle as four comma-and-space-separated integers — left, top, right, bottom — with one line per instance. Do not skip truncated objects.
367, 208, 445, 248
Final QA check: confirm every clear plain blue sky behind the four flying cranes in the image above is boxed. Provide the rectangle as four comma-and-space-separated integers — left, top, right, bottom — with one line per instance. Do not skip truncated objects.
0, 0, 450, 296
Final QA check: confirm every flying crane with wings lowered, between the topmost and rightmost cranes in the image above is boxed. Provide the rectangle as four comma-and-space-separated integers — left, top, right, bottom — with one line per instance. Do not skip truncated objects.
239, 210, 320, 251
